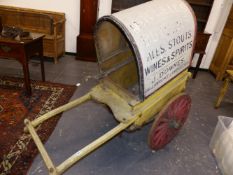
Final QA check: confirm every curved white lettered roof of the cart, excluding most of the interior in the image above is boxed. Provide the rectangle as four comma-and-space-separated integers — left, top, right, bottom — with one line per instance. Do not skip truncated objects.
95, 0, 196, 99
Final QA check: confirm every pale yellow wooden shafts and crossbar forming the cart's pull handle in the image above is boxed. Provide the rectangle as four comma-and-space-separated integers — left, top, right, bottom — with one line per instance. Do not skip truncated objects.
24, 93, 138, 175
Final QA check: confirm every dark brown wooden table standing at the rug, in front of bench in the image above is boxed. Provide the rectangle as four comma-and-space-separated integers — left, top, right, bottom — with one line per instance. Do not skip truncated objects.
0, 33, 45, 95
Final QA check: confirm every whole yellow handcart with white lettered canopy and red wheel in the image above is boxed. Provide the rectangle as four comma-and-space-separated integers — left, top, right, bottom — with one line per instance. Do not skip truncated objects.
25, 0, 196, 175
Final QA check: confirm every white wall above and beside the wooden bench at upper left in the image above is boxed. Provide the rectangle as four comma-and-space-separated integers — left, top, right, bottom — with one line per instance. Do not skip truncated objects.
0, 0, 80, 53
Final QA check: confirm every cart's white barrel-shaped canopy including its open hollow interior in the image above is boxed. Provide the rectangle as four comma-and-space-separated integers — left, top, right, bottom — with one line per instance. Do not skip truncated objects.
95, 0, 196, 101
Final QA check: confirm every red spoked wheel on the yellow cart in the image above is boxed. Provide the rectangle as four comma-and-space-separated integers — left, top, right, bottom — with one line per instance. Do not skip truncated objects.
148, 93, 191, 150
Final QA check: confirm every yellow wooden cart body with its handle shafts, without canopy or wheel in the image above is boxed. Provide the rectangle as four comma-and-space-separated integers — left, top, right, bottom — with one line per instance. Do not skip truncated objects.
25, 70, 191, 175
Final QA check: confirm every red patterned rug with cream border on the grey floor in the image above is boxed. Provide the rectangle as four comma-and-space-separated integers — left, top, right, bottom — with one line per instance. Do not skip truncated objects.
0, 77, 76, 175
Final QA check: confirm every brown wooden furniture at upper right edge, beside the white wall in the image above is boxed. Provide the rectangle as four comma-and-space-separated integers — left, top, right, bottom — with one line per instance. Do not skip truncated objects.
210, 8, 233, 80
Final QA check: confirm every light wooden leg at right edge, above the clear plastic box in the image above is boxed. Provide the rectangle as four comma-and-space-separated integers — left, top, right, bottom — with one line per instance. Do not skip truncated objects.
215, 70, 233, 108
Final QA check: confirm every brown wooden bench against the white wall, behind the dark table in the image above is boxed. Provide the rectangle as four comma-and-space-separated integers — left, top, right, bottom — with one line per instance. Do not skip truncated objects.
0, 5, 65, 63
